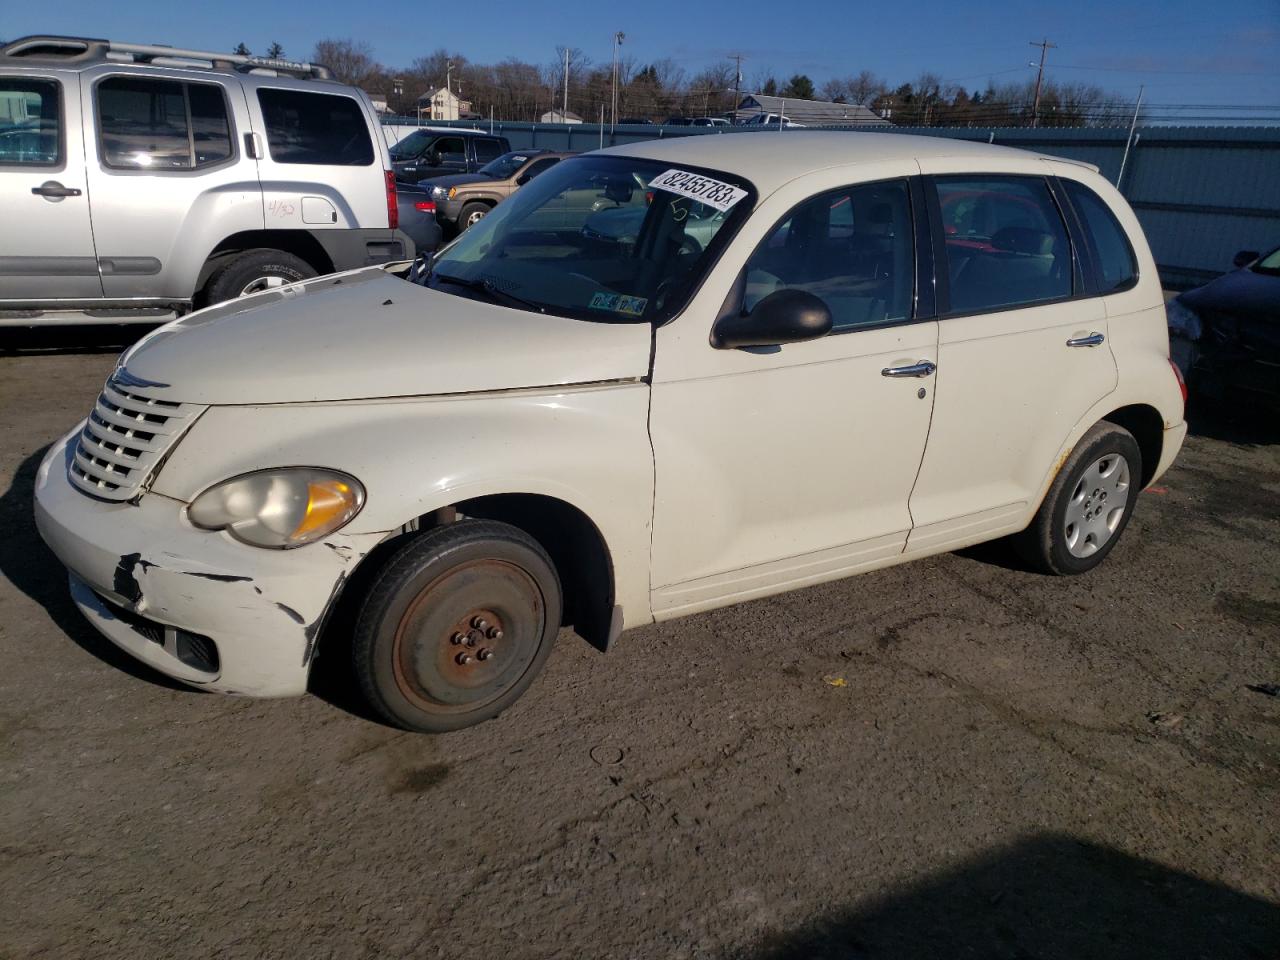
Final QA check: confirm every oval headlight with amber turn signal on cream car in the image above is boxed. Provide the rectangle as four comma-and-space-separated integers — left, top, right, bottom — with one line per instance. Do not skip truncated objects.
187, 467, 365, 550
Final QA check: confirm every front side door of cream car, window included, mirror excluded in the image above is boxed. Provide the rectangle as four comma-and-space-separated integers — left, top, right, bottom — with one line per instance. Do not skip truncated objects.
650, 179, 938, 618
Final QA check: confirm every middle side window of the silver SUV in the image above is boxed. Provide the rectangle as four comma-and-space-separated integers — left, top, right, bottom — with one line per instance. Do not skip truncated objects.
97, 77, 234, 170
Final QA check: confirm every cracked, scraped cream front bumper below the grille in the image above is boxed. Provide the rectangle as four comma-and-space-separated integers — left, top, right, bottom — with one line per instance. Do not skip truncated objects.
36, 428, 380, 696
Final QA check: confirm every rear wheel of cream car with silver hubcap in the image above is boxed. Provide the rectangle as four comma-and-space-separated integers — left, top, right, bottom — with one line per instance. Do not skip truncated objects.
1014, 421, 1142, 576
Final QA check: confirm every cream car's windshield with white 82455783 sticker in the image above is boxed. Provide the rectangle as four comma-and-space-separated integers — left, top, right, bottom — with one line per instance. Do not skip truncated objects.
425, 155, 755, 323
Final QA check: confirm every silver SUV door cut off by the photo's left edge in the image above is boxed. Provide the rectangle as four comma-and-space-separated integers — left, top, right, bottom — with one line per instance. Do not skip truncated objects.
0, 70, 102, 302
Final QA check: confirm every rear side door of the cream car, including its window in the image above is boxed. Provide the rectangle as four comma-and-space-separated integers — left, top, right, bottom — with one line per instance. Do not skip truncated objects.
908, 175, 1116, 553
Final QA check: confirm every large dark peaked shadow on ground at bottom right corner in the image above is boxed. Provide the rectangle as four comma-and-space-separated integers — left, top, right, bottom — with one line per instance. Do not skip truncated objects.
727, 833, 1280, 960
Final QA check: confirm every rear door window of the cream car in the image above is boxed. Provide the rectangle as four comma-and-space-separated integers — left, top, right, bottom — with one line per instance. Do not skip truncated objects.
934, 177, 1074, 314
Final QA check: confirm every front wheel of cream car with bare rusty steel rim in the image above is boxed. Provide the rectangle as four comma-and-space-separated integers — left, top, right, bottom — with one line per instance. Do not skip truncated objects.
353, 520, 561, 732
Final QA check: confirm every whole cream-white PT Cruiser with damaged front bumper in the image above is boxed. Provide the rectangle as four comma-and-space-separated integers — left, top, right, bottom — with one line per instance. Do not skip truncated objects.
36, 132, 1185, 731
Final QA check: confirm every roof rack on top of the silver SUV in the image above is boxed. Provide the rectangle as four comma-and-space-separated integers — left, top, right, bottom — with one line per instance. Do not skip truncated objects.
0, 36, 333, 79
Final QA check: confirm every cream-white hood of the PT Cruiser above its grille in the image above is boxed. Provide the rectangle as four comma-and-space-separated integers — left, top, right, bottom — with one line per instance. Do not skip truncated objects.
115, 268, 652, 404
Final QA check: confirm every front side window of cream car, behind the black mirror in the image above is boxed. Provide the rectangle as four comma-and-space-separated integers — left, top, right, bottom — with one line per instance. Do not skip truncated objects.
742, 180, 915, 330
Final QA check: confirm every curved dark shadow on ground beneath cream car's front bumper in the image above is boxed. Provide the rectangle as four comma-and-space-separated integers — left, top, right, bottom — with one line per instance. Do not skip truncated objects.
0, 447, 189, 692
